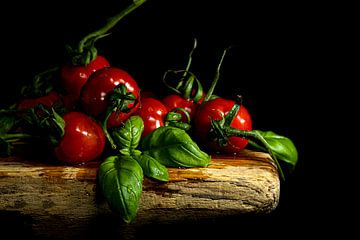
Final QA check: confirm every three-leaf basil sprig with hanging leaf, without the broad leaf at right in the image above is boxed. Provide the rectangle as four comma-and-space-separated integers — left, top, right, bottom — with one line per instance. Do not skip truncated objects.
99, 116, 169, 223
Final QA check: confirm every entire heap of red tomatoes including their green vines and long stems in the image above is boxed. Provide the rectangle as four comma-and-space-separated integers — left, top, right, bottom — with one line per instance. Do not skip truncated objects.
0, 1, 252, 164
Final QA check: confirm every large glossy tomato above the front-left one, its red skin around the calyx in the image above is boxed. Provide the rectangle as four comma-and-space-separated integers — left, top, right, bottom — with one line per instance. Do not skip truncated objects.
80, 67, 139, 128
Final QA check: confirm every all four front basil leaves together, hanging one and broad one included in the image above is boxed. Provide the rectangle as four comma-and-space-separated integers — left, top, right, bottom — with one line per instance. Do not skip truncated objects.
98, 116, 211, 223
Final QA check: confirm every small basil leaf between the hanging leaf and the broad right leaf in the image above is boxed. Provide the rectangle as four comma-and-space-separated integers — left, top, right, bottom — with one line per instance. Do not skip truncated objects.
136, 153, 169, 182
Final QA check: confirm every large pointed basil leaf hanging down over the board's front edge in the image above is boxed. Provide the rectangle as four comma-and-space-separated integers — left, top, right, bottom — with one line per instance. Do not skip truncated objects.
99, 156, 143, 223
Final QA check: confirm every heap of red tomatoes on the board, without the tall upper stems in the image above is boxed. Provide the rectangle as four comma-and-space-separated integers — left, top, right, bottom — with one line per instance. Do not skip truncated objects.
7, 42, 252, 167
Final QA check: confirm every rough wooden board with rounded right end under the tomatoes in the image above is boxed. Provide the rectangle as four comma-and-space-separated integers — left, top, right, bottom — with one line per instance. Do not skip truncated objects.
0, 150, 280, 238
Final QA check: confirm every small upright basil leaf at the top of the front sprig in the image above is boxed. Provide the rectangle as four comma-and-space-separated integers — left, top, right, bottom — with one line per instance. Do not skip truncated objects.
112, 116, 144, 152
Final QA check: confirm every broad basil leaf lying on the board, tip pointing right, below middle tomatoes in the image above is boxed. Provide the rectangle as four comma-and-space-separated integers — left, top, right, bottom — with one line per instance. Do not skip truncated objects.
141, 126, 211, 167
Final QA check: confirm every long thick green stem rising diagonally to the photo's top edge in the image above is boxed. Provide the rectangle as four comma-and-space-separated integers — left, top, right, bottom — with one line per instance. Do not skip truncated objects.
78, 0, 146, 58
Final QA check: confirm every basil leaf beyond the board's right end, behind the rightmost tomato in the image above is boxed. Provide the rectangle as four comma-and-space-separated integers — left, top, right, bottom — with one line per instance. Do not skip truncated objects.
249, 130, 298, 168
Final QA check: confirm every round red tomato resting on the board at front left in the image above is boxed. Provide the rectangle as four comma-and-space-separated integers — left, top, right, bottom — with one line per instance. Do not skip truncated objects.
55, 112, 106, 164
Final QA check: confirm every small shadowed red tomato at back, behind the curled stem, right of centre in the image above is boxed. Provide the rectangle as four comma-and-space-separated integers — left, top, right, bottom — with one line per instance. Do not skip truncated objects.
162, 94, 198, 122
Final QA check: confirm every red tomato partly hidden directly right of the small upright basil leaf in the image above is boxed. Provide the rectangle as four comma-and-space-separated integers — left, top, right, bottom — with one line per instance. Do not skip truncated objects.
134, 97, 168, 137
